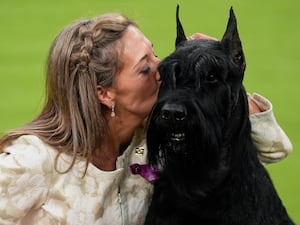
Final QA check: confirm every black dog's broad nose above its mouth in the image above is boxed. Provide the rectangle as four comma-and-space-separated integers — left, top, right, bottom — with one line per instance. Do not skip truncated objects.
161, 103, 187, 121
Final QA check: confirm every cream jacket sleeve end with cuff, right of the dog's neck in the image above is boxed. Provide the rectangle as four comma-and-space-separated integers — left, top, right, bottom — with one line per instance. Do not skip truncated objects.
250, 93, 292, 163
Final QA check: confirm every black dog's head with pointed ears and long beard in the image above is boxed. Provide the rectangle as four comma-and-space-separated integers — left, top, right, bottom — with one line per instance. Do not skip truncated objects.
147, 6, 248, 179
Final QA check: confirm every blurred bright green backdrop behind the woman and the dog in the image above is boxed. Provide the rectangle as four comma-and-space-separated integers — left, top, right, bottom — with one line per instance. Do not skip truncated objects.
0, 0, 300, 224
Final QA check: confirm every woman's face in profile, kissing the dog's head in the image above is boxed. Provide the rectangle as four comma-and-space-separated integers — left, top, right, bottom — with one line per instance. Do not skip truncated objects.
113, 26, 160, 120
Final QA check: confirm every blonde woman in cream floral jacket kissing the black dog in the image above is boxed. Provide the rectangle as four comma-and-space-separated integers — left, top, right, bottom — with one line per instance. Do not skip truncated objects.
0, 14, 291, 225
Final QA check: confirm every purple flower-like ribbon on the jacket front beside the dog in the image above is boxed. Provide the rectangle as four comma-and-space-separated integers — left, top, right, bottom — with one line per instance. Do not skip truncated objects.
130, 163, 159, 183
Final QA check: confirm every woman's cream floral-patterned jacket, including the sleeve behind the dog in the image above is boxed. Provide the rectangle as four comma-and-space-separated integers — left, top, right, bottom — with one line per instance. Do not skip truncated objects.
0, 95, 292, 225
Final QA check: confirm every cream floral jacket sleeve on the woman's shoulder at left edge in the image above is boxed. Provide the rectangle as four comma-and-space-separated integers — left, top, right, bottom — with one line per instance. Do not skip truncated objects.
0, 134, 51, 225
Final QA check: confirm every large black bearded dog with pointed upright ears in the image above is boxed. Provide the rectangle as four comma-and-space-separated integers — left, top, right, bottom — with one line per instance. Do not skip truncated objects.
145, 5, 293, 225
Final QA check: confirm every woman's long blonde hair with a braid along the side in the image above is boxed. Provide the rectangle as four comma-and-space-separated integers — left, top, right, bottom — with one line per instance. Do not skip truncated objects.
0, 13, 136, 175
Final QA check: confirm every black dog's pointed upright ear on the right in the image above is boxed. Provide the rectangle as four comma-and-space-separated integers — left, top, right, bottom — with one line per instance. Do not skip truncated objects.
221, 7, 245, 69
